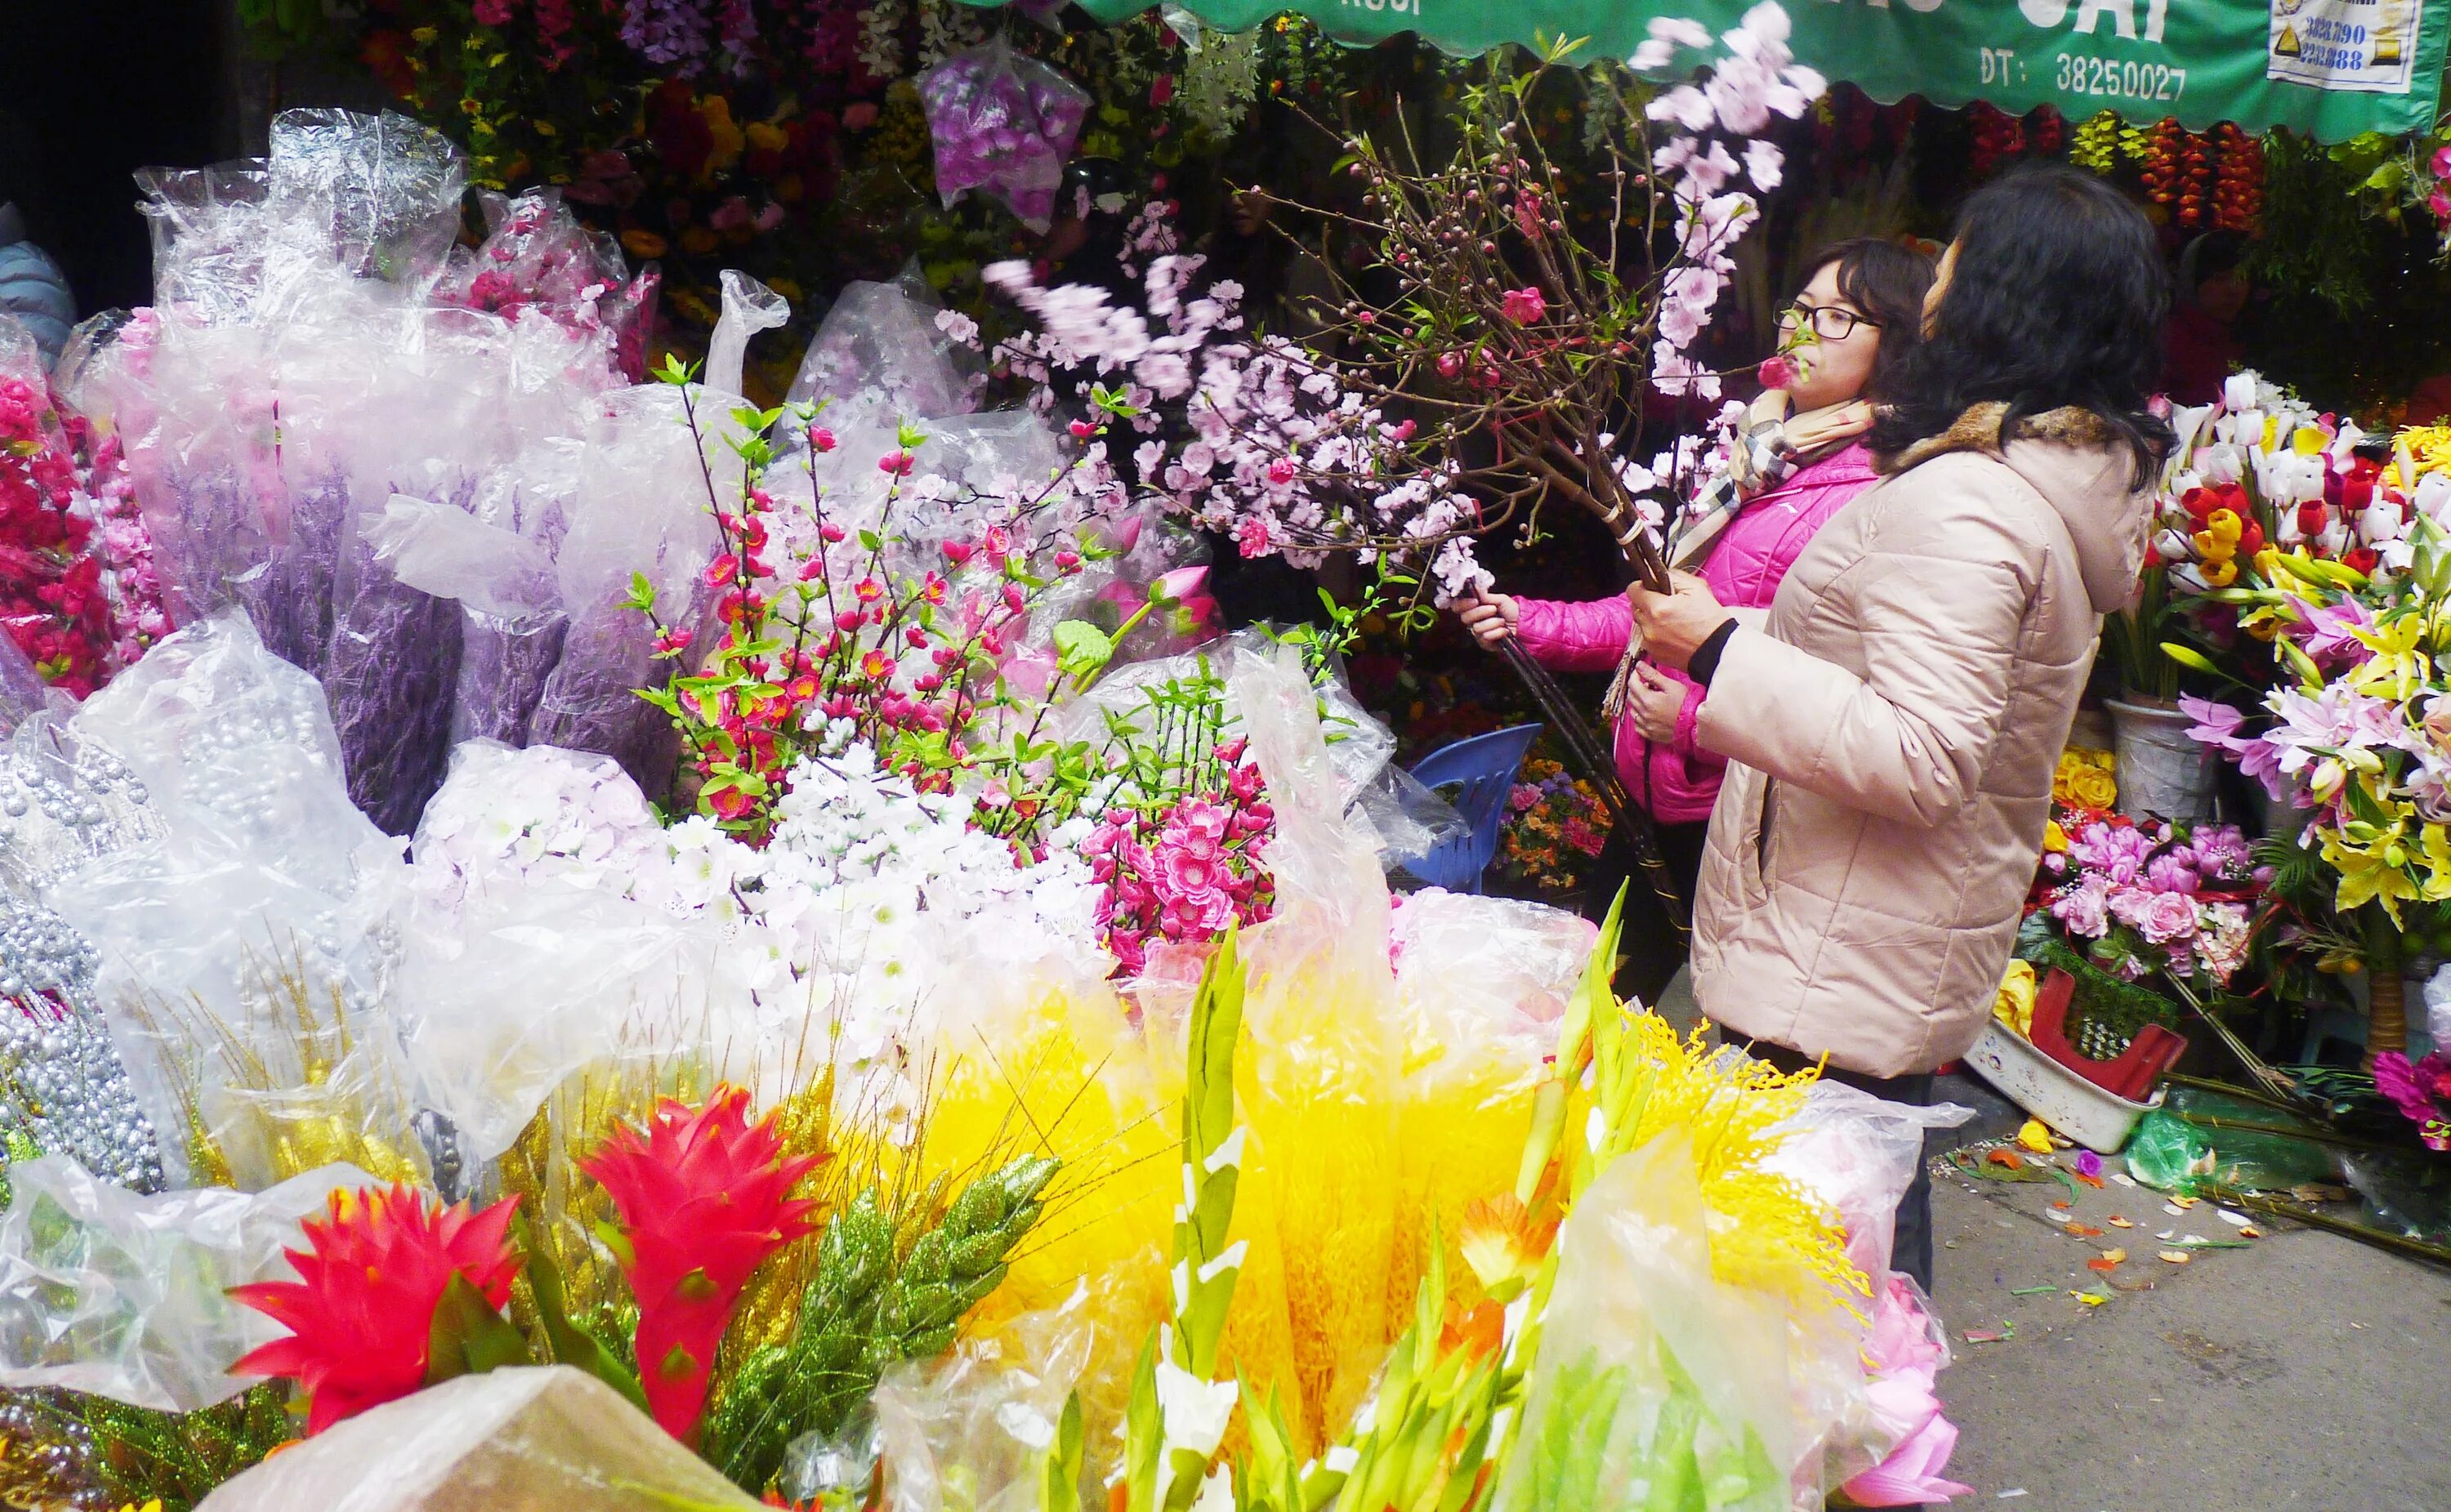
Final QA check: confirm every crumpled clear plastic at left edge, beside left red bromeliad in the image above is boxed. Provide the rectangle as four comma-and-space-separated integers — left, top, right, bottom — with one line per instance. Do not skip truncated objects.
0, 1154, 373, 1412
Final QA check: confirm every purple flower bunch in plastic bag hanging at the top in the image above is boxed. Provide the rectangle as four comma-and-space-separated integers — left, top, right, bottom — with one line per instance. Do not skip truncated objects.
919, 37, 1088, 230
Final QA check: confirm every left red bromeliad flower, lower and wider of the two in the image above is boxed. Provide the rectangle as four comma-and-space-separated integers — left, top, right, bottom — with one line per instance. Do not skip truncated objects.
230, 1186, 520, 1434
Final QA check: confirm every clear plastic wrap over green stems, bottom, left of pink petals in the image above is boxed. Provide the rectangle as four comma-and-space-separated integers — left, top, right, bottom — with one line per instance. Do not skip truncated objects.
1495, 1130, 1789, 1512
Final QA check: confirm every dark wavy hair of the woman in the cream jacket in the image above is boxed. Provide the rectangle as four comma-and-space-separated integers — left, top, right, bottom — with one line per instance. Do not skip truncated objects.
1870, 164, 2174, 488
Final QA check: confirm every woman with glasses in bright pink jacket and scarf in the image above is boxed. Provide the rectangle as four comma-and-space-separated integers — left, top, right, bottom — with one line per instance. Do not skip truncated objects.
1463, 238, 1931, 956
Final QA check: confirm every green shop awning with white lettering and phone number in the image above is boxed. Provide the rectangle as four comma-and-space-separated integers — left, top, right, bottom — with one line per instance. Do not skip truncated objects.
1076, 0, 2451, 142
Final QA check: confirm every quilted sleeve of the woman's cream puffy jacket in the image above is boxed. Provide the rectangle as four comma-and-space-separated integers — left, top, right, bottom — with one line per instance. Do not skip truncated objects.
1696, 456, 2047, 826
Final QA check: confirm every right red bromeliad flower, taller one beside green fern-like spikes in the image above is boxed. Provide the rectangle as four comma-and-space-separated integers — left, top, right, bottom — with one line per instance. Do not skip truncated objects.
578, 1088, 819, 1443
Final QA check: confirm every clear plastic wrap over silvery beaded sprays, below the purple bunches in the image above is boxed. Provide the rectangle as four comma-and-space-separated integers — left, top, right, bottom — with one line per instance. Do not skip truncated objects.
47, 613, 397, 1181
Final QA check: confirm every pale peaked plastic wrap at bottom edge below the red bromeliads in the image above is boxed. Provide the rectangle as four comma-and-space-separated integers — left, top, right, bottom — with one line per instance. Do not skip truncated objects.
199, 1365, 757, 1512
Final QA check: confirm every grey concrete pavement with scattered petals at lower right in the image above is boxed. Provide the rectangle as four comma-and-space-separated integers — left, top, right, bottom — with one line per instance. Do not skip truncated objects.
1934, 1108, 2451, 1512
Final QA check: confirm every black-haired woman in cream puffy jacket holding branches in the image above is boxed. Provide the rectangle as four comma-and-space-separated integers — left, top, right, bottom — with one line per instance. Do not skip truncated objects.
1630, 167, 2169, 1287
